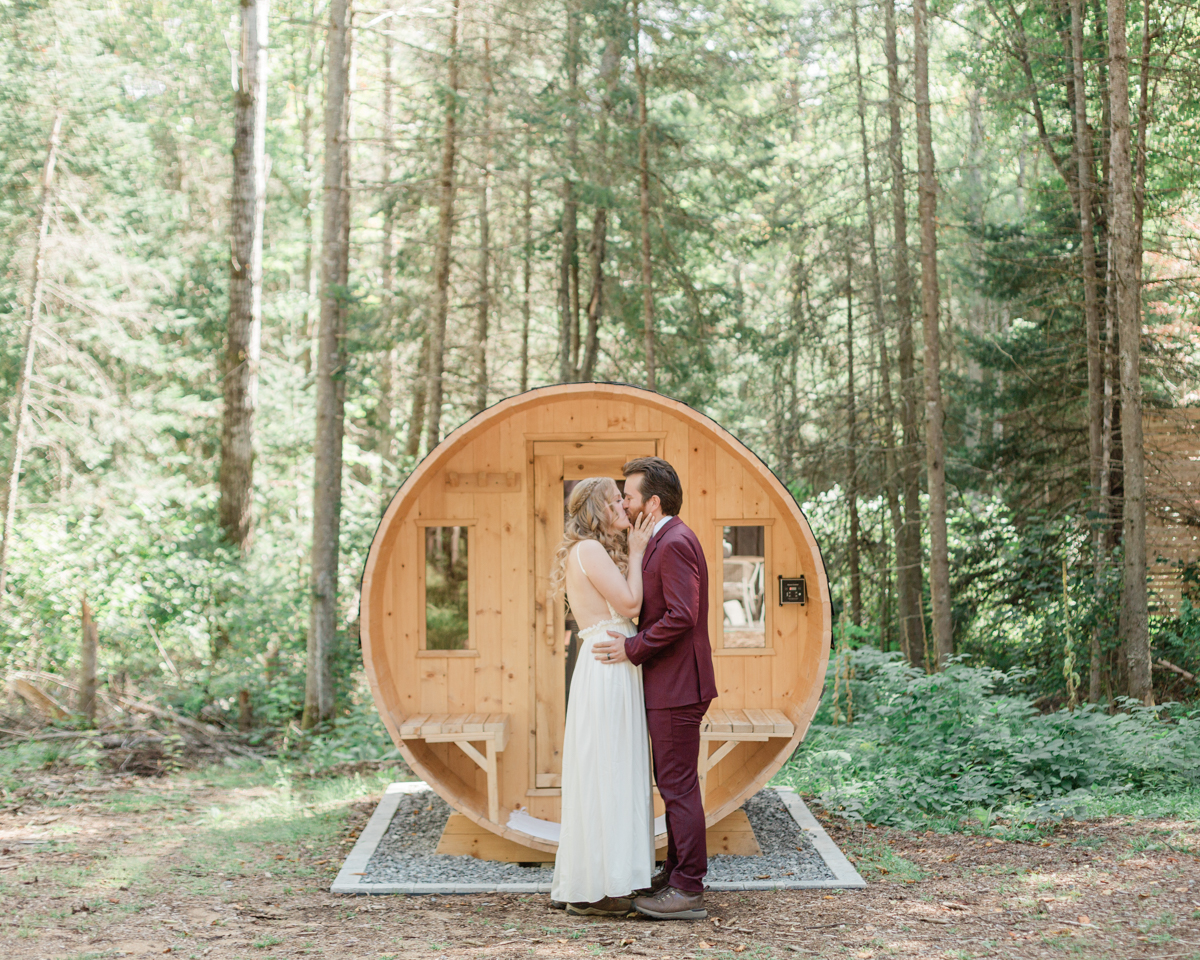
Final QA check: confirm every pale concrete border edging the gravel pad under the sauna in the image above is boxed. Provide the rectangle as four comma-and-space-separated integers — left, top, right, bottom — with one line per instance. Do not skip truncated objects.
329, 780, 866, 895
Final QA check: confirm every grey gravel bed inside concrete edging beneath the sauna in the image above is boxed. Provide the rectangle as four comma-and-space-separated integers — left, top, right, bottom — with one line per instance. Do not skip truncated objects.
361, 790, 833, 883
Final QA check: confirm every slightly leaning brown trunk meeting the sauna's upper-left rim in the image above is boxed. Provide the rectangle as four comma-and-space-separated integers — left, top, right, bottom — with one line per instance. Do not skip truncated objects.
425, 0, 462, 452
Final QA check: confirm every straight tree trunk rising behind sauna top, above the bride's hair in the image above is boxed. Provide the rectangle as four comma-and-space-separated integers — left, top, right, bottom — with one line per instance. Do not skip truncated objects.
558, 0, 580, 383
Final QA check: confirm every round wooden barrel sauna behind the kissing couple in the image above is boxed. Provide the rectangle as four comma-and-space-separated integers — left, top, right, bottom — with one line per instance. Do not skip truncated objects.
361, 383, 830, 859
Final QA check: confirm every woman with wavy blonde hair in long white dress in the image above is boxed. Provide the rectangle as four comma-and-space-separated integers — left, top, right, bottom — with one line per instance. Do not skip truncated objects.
551, 476, 654, 917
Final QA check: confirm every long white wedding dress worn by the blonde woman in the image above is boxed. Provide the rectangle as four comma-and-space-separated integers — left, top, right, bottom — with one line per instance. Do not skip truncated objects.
550, 552, 654, 904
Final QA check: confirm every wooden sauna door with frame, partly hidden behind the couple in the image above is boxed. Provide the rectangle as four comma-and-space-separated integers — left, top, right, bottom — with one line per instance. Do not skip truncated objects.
532, 438, 658, 793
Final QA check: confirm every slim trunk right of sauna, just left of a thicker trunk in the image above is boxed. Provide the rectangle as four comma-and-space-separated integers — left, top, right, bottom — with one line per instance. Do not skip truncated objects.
883, 0, 925, 666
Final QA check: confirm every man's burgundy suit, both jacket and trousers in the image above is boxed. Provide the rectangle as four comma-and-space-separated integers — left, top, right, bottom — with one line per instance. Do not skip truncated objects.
625, 517, 716, 893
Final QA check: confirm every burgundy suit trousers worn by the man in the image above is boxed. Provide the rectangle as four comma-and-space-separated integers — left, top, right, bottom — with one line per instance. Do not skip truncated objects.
646, 700, 712, 893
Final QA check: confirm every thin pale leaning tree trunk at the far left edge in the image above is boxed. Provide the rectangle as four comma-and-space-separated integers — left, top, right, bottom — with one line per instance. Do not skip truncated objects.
0, 110, 62, 595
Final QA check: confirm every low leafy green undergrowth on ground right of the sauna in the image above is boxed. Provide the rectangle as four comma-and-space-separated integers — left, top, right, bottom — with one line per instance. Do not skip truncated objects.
780, 649, 1200, 827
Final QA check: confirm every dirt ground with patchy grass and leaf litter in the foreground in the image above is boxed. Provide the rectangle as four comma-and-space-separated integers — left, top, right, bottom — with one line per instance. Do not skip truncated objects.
0, 772, 1200, 960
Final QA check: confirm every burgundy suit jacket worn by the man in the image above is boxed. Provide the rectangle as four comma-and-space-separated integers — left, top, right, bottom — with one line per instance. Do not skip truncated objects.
625, 517, 716, 710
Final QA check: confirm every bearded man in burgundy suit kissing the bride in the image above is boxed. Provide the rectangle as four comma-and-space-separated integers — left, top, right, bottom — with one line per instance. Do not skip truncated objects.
592, 457, 716, 920
